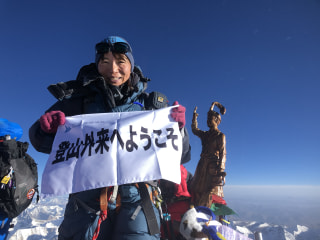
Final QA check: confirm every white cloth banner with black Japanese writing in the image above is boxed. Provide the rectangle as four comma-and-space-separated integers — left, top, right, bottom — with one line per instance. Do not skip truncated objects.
41, 106, 182, 195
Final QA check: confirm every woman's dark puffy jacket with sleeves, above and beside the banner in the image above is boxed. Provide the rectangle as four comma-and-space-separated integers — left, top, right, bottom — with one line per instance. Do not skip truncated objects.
29, 63, 191, 163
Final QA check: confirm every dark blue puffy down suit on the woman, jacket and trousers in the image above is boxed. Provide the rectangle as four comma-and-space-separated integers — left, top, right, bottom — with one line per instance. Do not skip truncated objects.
29, 64, 191, 240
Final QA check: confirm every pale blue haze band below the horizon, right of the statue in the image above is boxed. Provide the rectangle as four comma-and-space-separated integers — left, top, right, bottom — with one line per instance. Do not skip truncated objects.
224, 186, 320, 228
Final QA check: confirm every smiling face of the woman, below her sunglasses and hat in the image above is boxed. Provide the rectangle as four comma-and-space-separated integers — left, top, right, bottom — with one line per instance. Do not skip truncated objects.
98, 52, 131, 86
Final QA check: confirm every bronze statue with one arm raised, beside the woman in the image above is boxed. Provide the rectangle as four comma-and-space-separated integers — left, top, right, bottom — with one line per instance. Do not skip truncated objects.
191, 102, 226, 208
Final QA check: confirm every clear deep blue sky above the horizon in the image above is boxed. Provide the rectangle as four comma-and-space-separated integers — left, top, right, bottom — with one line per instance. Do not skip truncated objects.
0, 0, 320, 185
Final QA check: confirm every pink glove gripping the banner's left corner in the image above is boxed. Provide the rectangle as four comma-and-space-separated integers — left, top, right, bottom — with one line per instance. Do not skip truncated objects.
40, 111, 66, 133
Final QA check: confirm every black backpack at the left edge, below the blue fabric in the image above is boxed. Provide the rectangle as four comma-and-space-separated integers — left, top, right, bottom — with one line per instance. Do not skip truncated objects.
0, 137, 39, 218
